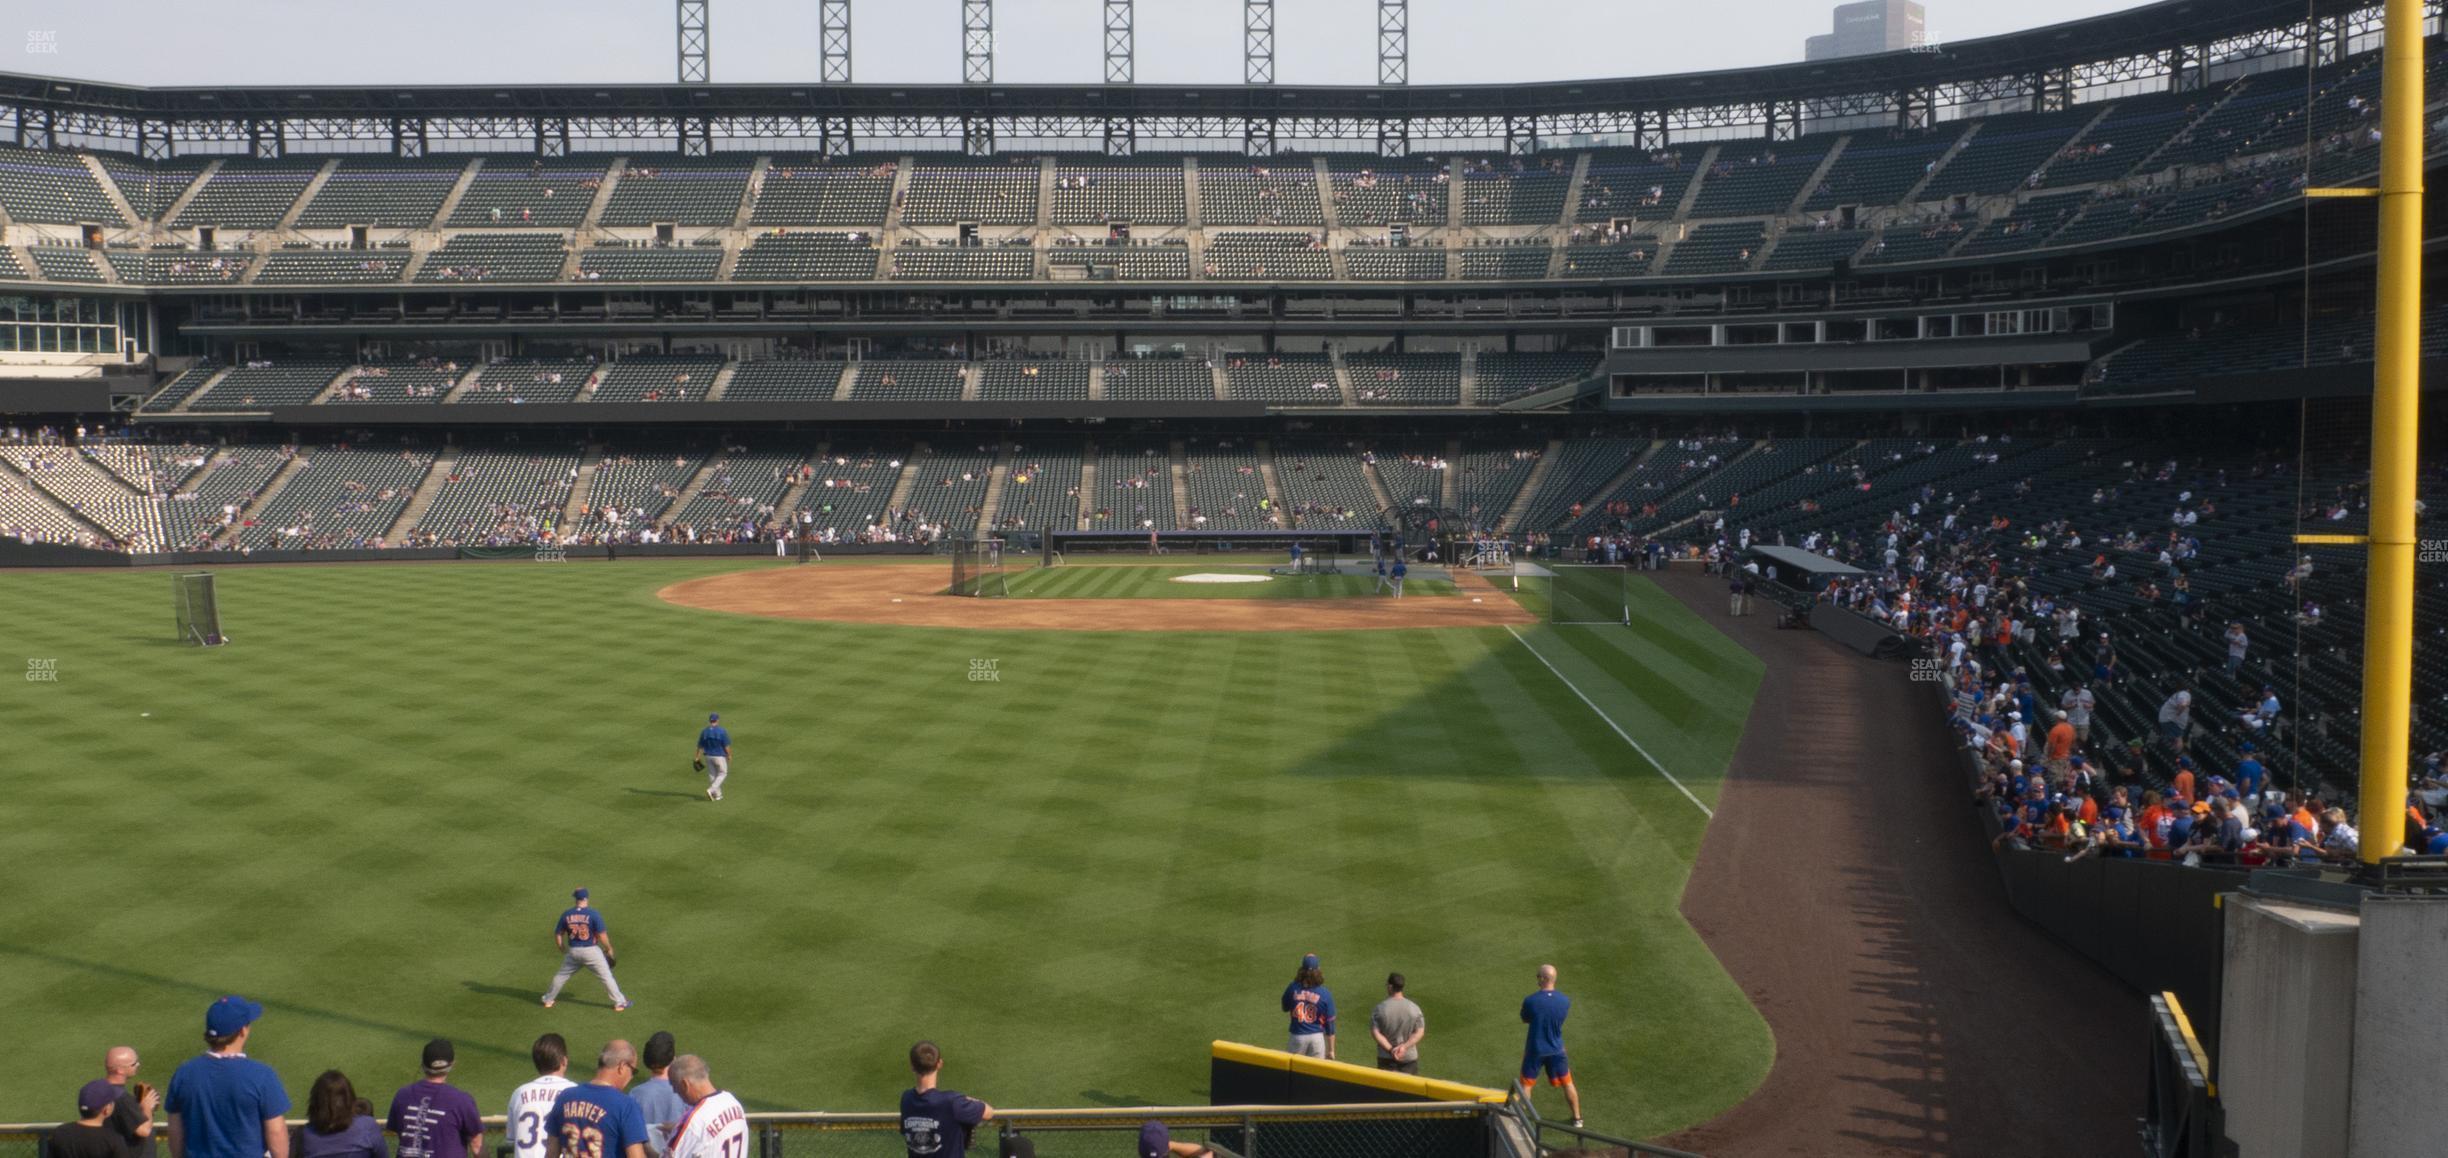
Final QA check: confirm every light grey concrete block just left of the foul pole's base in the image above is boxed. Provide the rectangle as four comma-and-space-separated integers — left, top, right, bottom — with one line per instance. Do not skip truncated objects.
2211, 894, 2359, 1158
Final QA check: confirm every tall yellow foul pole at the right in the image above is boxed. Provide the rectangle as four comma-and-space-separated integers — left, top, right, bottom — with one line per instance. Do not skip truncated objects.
2357, 0, 2424, 864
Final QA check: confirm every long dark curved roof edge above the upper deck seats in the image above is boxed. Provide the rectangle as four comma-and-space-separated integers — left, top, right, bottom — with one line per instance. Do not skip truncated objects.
0, 0, 2370, 120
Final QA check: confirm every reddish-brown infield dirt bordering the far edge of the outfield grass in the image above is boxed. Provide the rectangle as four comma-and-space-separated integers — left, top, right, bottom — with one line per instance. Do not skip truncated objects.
656, 566, 1537, 632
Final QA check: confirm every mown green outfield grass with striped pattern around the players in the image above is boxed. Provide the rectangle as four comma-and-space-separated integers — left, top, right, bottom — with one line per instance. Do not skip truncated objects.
0, 561, 1772, 1136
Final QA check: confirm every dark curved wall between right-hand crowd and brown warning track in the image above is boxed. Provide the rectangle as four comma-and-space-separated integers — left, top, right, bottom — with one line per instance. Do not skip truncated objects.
1929, 683, 2245, 1058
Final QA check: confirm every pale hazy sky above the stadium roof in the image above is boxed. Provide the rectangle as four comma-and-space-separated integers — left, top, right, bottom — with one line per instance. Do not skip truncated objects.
0, 0, 2140, 86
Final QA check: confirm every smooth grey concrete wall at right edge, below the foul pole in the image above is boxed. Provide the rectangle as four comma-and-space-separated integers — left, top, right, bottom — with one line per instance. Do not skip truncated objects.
2348, 896, 2448, 1158
